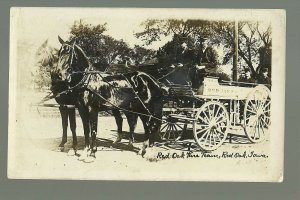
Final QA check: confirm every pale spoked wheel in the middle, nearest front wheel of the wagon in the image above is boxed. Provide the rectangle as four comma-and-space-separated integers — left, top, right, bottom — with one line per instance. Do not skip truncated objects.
193, 101, 230, 151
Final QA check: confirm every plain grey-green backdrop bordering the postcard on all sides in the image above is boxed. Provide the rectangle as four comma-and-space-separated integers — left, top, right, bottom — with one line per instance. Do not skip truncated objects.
1, 1, 299, 199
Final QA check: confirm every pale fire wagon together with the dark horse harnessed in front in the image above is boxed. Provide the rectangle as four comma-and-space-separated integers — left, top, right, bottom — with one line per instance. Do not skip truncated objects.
41, 39, 271, 157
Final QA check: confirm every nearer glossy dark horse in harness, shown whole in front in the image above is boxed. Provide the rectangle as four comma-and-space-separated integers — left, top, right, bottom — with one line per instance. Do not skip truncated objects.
55, 36, 163, 160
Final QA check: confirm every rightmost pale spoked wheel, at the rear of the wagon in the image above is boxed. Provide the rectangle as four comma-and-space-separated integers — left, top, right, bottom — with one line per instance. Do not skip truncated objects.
244, 85, 271, 143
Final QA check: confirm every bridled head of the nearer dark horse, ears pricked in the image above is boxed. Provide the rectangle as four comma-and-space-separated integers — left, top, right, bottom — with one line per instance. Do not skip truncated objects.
54, 36, 90, 83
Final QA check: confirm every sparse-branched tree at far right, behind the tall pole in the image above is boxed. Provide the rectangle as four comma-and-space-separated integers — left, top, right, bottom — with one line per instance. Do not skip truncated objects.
210, 21, 271, 79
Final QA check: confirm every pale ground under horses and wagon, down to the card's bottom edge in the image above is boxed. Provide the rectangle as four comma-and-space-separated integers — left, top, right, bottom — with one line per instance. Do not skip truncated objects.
8, 94, 271, 181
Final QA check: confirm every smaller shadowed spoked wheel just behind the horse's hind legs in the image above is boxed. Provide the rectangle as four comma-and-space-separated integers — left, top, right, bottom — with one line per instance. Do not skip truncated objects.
159, 116, 186, 142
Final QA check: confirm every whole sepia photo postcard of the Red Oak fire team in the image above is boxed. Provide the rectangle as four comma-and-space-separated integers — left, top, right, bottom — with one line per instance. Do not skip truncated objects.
8, 8, 286, 182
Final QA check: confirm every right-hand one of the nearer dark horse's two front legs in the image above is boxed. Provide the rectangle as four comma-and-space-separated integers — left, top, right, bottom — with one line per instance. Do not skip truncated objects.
89, 109, 98, 158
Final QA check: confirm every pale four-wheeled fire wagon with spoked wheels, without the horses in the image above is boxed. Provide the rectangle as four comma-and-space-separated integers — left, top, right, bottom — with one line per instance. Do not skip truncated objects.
160, 77, 271, 151
